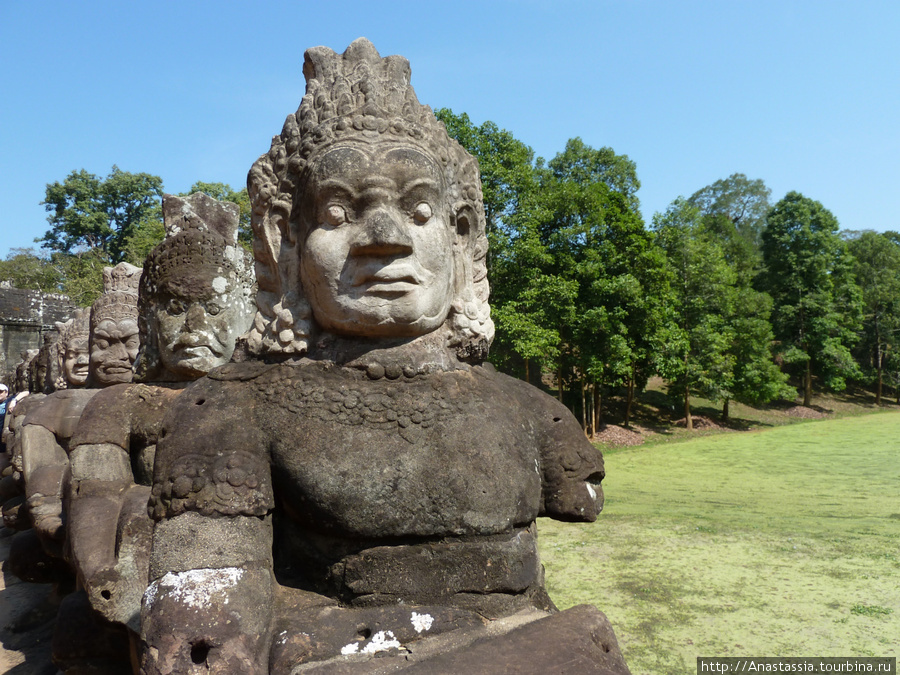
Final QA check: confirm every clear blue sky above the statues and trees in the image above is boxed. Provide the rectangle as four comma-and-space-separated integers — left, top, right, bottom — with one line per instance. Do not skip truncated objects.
0, 0, 900, 256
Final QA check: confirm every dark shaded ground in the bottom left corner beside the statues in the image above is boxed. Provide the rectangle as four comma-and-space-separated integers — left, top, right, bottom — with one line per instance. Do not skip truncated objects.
0, 526, 57, 675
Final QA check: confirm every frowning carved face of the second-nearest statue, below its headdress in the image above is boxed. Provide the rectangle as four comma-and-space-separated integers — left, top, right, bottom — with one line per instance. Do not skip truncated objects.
152, 277, 241, 379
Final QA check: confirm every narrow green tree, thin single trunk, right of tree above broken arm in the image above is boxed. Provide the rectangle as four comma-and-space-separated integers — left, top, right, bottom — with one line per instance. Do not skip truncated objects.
653, 198, 736, 429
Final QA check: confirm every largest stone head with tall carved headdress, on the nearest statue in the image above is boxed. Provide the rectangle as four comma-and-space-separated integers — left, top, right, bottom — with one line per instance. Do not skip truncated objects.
248, 38, 493, 360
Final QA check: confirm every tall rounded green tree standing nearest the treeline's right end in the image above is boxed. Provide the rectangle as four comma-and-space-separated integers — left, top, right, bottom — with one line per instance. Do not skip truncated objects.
762, 192, 861, 406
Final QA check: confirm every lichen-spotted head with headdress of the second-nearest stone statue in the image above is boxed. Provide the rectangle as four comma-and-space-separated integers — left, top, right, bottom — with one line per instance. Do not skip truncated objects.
135, 192, 256, 382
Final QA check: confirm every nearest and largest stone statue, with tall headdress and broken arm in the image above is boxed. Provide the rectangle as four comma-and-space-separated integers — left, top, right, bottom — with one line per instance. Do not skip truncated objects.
141, 39, 628, 675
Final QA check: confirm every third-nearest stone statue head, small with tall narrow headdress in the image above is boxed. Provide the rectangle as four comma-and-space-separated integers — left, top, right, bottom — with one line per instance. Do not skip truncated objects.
89, 262, 141, 387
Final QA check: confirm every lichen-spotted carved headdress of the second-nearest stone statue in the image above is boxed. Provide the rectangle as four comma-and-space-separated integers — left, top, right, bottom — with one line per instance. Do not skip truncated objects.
134, 192, 256, 382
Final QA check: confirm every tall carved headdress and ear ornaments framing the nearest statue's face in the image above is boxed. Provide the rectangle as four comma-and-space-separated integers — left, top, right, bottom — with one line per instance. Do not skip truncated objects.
247, 38, 494, 360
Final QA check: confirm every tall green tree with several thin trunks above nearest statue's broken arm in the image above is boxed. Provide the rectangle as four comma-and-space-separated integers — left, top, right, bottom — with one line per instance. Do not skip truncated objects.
541, 138, 669, 430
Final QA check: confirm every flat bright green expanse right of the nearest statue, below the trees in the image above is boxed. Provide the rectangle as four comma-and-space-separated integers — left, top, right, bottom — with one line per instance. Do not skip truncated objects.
538, 412, 900, 675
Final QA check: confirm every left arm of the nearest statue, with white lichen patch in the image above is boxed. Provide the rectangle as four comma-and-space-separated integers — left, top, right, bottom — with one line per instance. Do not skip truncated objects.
141, 412, 275, 675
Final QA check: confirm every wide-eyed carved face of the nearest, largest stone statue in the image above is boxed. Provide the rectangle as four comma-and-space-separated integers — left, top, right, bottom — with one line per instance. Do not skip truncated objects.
300, 145, 454, 337
